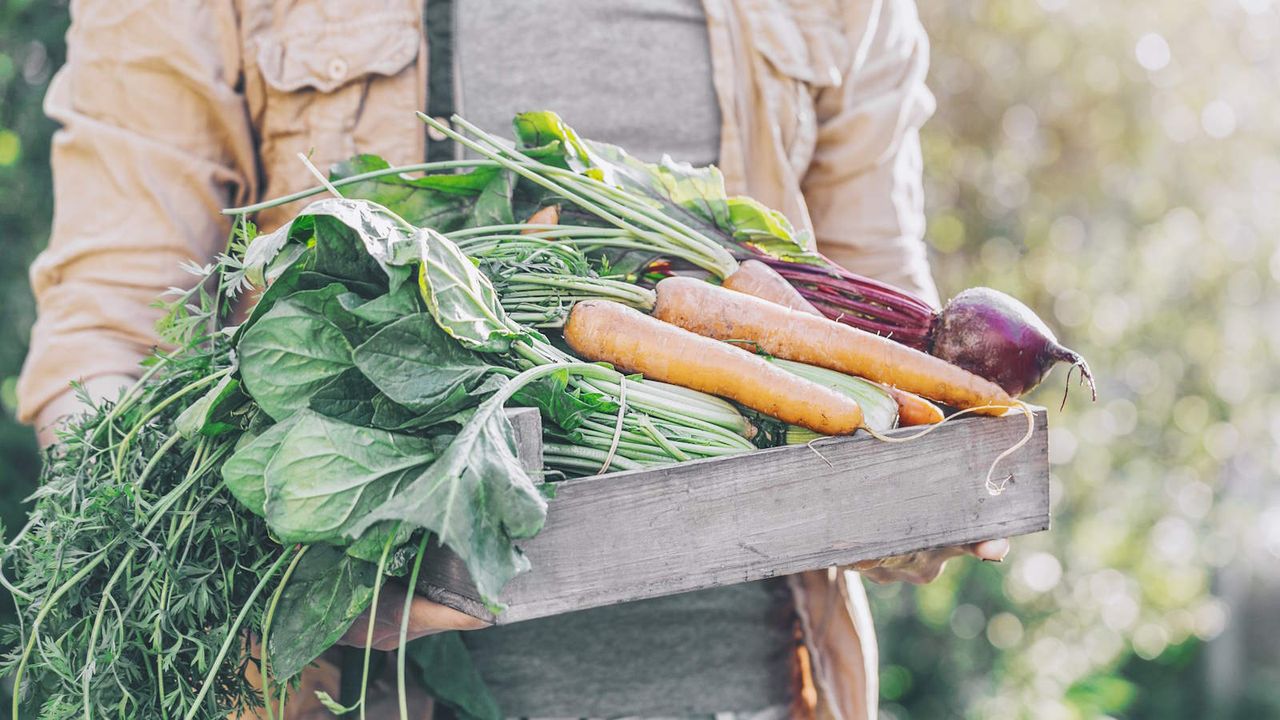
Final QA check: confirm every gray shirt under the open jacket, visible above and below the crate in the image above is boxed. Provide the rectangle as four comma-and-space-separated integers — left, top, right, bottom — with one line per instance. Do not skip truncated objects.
453, 0, 797, 717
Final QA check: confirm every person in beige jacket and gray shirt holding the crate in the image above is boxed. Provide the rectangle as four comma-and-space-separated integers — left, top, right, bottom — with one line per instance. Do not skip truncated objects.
18, 0, 1009, 720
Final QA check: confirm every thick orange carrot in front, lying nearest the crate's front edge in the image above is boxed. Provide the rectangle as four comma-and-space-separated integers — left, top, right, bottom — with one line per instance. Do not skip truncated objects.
564, 297, 863, 436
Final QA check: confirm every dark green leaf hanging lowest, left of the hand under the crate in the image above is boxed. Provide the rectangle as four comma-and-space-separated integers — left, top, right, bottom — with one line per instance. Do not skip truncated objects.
268, 544, 378, 679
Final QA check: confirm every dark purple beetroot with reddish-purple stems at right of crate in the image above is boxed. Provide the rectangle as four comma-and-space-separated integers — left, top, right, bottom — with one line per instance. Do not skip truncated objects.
764, 259, 1097, 401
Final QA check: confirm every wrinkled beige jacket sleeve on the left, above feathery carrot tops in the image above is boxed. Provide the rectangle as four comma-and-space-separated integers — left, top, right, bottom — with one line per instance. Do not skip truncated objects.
18, 0, 255, 421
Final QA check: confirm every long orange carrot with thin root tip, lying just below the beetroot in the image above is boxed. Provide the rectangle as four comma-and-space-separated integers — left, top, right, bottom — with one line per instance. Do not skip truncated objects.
653, 277, 1015, 414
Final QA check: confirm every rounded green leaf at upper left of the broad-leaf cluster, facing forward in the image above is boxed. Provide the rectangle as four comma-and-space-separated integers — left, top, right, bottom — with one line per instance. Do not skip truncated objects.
237, 286, 352, 420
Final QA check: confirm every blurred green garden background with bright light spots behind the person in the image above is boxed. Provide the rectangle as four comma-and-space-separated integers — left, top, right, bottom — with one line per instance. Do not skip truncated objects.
0, 0, 1280, 720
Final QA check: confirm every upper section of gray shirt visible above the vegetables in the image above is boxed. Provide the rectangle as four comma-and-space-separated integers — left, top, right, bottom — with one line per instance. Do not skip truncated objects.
453, 0, 721, 165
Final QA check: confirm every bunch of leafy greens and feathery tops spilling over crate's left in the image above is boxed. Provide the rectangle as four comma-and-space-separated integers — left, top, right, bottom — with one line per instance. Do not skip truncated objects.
3, 149, 753, 720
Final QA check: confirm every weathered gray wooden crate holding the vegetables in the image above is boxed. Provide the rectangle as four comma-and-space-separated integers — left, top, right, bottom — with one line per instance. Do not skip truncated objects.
419, 410, 1050, 624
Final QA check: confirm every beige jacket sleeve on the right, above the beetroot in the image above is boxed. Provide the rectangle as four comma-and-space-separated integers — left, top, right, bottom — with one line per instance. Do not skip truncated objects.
801, 0, 938, 305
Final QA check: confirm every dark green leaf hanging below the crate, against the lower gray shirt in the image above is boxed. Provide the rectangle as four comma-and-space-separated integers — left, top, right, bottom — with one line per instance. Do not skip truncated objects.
404, 632, 504, 720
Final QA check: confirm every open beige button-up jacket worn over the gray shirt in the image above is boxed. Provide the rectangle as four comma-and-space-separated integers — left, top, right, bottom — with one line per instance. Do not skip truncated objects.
18, 0, 936, 720
